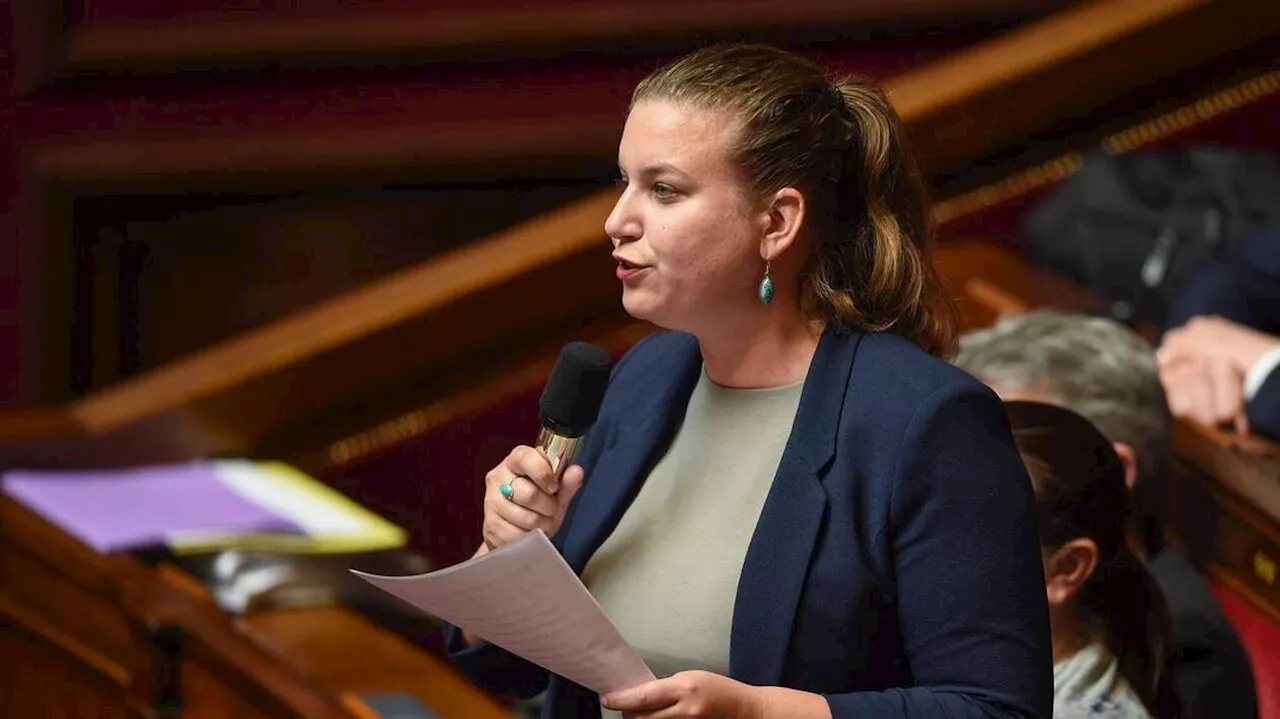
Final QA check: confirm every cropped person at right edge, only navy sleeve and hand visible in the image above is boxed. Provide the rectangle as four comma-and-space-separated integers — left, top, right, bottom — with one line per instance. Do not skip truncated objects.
1157, 225, 1280, 439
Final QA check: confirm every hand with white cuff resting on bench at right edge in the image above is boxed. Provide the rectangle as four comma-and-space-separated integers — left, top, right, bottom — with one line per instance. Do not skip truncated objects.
1160, 357, 1248, 434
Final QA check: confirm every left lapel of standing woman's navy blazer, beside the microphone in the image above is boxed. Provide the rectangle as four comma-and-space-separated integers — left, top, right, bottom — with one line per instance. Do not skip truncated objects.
562, 338, 703, 574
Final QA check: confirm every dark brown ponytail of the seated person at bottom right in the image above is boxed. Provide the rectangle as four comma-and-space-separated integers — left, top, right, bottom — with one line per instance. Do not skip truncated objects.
1079, 545, 1179, 719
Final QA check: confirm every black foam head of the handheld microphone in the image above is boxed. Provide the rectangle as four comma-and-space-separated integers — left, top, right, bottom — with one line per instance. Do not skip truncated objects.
538, 342, 609, 438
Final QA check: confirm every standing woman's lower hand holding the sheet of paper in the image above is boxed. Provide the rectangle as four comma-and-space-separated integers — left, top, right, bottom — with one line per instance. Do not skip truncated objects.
603, 672, 764, 719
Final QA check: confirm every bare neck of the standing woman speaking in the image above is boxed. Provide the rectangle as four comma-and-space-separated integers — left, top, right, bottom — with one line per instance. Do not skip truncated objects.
698, 307, 822, 389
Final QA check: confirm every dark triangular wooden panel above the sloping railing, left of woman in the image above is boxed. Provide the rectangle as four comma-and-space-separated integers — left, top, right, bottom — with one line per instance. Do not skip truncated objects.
73, 182, 599, 391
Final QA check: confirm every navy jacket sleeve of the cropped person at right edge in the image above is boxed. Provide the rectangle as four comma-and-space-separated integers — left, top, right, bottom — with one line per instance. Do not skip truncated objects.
1165, 224, 1280, 439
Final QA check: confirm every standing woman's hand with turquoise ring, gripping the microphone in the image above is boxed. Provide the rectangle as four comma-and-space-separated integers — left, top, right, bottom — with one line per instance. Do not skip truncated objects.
477, 445, 582, 554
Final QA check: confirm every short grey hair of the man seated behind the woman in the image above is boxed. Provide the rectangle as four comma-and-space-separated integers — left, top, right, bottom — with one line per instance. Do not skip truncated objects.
955, 310, 1172, 482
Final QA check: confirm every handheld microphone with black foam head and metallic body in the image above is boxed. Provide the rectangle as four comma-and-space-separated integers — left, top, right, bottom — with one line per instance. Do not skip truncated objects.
536, 342, 611, 481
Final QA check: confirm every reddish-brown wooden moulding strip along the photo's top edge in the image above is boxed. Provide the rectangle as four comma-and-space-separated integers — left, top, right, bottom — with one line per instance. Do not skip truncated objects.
44, 0, 1066, 79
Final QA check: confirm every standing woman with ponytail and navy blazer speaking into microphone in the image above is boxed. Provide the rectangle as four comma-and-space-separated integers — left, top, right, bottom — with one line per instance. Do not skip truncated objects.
448, 46, 1052, 719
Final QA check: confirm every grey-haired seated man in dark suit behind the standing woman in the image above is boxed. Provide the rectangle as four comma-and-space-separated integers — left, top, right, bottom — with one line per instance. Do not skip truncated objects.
956, 311, 1257, 719
